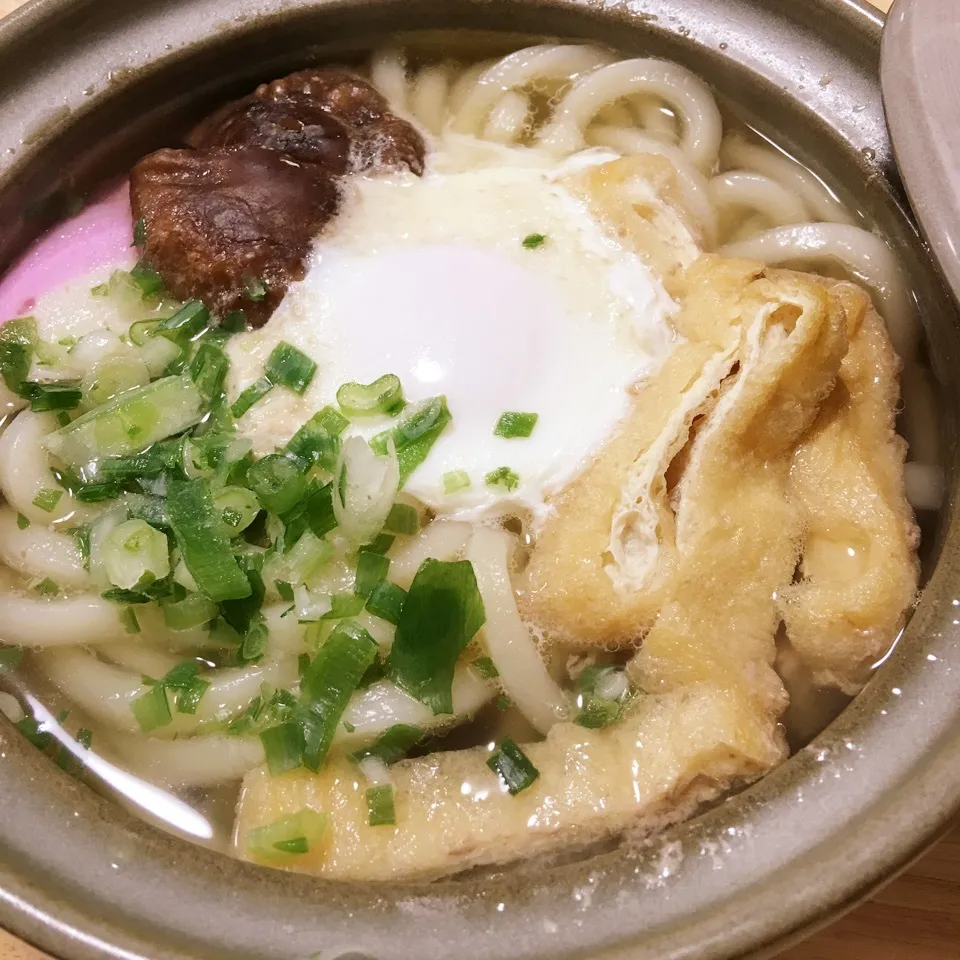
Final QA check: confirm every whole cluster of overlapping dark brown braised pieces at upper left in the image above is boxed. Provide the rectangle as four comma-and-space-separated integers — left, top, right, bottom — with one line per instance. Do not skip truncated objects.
130, 68, 425, 326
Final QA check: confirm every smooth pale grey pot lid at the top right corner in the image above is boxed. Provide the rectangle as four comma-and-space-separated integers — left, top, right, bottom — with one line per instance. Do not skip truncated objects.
880, 0, 960, 300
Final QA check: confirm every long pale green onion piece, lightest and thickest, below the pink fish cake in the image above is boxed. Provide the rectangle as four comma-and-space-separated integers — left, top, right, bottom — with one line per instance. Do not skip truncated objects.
44, 376, 206, 469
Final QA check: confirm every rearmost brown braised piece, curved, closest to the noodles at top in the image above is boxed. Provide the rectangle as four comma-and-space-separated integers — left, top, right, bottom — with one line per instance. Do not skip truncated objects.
254, 67, 426, 176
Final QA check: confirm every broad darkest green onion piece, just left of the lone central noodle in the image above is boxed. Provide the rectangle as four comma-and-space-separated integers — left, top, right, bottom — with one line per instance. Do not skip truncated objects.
388, 559, 486, 714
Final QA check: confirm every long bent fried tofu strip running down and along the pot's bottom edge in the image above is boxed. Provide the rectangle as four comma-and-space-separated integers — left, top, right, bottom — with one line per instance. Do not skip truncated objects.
234, 264, 846, 880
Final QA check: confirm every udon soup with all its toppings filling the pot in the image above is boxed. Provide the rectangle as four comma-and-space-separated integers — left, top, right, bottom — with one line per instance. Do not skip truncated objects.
0, 44, 937, 879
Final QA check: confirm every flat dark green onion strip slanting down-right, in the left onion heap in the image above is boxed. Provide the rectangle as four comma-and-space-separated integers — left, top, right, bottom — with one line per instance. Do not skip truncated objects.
167, 479, 251, 603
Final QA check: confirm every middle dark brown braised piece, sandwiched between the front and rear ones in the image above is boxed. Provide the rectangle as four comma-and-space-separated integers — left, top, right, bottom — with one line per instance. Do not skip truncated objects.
187, 93, 350, 175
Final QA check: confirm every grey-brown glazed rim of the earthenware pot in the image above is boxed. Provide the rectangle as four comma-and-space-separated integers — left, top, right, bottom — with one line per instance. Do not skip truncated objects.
0, 0, 960, 960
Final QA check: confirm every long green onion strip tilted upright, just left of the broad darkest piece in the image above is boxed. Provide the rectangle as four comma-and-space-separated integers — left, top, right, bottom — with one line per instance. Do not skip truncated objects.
300, 621, 378, 770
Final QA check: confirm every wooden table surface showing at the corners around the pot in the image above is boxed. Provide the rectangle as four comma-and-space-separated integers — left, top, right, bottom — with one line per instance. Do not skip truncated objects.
7, 0, 960, 960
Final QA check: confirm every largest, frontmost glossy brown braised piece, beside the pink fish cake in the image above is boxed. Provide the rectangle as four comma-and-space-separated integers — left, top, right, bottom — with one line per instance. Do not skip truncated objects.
130, 147, 340, 326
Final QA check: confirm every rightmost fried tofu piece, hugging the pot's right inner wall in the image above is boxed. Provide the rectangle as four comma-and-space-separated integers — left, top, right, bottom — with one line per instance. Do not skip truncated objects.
780, 281, 920, 693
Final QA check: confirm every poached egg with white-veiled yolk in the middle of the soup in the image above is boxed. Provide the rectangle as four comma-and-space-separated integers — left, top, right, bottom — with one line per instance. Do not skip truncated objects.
228, 149, 675, 518
